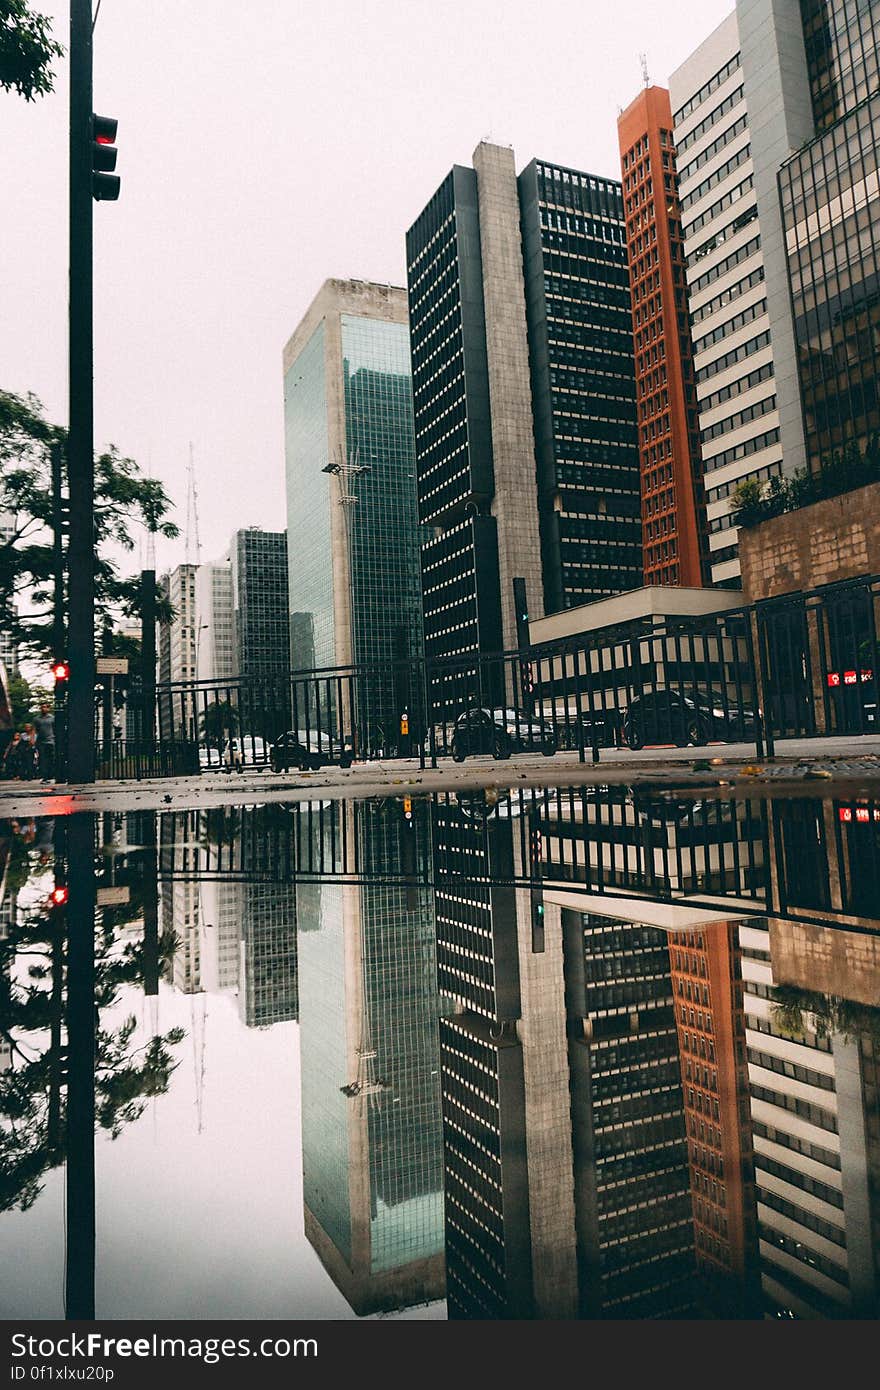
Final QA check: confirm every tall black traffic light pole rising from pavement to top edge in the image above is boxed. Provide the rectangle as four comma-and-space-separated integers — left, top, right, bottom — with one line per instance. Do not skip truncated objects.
67, 0, 95, 783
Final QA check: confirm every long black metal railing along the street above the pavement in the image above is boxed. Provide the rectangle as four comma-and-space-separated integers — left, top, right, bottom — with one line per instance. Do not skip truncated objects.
99, 577, 880, 777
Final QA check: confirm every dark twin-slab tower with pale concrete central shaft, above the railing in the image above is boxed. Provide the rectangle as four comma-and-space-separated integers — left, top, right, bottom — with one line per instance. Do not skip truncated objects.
406, 143, 641, 700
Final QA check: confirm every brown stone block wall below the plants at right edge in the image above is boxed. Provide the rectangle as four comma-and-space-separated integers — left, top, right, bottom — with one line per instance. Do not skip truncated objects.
740, 482, 880, 603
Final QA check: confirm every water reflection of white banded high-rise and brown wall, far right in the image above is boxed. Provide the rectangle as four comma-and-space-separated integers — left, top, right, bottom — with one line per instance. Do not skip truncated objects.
740, 920, 880, 1318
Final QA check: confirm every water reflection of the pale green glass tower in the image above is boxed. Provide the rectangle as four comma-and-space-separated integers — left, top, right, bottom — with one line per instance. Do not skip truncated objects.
298, 803, 445, 1315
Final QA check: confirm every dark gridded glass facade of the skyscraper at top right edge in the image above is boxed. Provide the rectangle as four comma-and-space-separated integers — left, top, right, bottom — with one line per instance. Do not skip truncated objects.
779, 0, 880, 468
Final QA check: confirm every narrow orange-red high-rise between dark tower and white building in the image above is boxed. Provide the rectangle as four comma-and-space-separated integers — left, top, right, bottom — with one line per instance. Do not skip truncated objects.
617, 86, 709, 588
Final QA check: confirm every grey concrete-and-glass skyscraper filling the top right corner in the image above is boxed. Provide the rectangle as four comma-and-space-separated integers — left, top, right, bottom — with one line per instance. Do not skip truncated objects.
756, 0, 880, 470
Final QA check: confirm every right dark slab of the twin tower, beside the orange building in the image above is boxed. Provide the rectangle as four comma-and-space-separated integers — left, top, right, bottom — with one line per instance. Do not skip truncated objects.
519, 160, 642, 613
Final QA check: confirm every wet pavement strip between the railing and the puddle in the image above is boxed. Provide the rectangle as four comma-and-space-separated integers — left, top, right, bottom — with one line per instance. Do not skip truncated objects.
0, 734, 880, 819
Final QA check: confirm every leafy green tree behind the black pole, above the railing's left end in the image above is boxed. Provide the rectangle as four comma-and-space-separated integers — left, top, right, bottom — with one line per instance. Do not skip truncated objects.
0, 386, 179, 656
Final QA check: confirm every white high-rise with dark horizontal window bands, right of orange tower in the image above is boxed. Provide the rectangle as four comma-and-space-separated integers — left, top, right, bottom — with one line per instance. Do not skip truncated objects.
669, 14, 804, 588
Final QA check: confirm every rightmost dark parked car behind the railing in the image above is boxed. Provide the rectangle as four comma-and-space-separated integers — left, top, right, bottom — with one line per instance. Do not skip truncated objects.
623, 688, 755, 748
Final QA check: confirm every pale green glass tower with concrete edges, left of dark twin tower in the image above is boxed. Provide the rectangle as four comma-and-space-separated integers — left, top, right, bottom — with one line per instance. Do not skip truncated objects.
284, 279, 421, 689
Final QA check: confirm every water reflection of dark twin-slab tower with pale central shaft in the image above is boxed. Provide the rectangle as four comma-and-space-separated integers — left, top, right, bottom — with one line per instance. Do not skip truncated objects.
434, 801, 694, 1318
